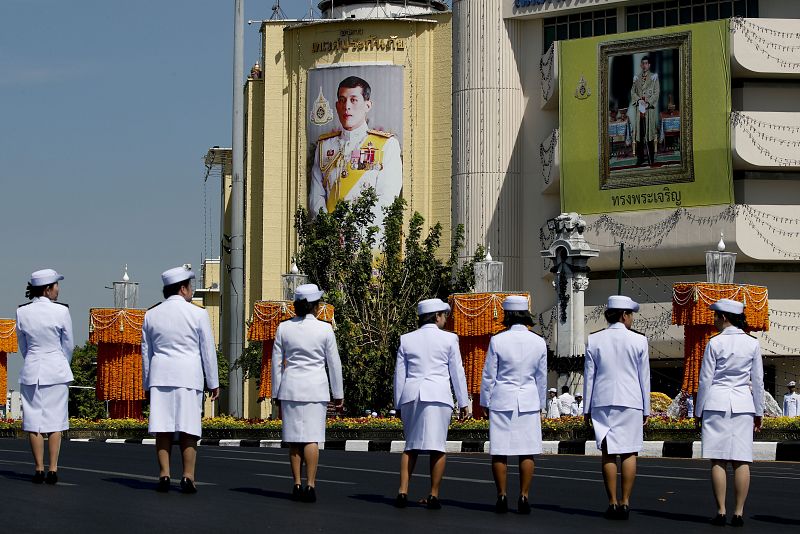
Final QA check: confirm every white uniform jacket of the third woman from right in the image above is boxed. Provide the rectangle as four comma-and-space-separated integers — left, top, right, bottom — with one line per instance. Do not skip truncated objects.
481, 325, 547, 412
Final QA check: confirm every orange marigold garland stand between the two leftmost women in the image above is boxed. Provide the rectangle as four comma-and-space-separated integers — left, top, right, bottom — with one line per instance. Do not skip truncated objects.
89, 308, 145, 419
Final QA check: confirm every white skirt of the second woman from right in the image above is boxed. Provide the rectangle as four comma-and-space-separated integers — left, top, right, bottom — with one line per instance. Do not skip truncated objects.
592, 406, 644, 454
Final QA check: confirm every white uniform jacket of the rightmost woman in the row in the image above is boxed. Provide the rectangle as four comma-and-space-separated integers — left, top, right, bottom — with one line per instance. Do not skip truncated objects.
694, 326, 764, 417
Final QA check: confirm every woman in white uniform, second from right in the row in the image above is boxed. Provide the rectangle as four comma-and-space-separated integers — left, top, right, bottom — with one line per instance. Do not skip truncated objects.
583, 295, 650, 520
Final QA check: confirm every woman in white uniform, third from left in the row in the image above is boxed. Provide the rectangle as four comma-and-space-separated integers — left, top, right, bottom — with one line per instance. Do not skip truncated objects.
272, 284, 344, 502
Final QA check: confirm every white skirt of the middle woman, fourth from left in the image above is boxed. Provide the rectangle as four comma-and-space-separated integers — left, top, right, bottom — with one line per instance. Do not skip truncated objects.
400, 398, 453, 452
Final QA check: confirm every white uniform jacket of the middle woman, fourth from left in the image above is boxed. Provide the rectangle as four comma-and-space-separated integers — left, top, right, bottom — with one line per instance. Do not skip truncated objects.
394, 324, 469, 408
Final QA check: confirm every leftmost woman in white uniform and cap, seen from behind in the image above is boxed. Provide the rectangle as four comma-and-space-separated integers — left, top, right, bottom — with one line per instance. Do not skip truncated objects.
17, 269, 75, 484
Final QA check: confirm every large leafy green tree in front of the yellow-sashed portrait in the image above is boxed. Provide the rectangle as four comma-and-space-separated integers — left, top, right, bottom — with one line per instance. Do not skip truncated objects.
295, 188, 484, 413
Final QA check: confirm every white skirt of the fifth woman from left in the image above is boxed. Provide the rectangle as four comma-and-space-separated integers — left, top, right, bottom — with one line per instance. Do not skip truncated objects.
489, 408, 542, 456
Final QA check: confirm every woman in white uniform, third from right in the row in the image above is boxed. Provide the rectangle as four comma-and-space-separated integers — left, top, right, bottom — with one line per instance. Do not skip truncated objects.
481, 295, 547, 514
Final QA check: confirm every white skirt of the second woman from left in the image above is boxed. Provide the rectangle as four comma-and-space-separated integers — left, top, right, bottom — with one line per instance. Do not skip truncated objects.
147, 386, 203, 437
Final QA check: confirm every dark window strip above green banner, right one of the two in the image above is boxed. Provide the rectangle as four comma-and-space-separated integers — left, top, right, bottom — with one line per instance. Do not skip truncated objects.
625, 0, 758, 32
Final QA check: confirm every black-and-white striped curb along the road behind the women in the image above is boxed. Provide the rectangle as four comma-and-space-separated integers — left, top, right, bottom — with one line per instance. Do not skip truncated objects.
68, 438, 800, 462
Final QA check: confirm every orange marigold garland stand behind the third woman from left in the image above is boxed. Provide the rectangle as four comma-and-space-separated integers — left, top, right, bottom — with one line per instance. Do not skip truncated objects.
247, 300, 336, 399
